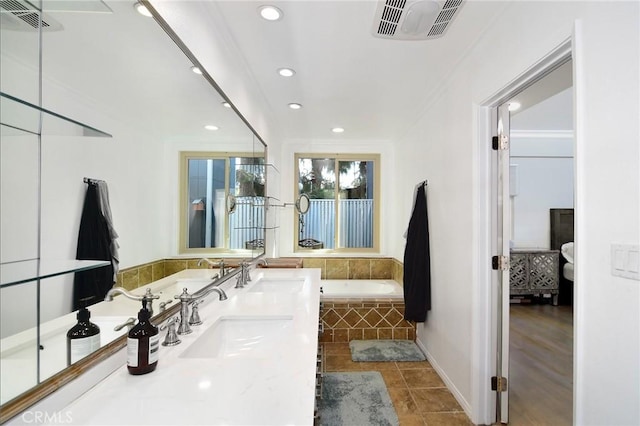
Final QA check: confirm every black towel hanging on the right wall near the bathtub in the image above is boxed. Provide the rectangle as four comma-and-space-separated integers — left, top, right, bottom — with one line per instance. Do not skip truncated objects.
404, 183, 431, 322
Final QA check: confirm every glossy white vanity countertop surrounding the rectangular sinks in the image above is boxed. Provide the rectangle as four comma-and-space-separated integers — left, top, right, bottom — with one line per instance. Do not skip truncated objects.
47, 269, 320, 425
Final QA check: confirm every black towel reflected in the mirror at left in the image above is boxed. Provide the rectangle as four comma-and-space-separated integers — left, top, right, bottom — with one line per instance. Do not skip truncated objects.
73, 182, 113, 310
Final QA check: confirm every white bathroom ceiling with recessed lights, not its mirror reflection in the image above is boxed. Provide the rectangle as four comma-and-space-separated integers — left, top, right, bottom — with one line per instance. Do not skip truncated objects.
200, 0, 505, 140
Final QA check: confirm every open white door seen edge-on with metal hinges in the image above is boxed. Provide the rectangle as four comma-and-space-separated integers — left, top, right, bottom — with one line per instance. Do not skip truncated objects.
492, 104, 511, 423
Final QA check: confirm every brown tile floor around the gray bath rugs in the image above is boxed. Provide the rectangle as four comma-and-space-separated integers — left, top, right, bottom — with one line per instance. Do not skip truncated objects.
322, 343, 473, 426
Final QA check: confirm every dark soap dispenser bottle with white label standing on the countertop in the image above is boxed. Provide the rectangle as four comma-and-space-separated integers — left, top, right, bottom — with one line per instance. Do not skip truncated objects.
127, 299, 160, 375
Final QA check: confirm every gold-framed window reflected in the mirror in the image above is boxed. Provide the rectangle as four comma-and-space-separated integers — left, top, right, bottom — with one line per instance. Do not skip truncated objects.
180, 152, 265, 253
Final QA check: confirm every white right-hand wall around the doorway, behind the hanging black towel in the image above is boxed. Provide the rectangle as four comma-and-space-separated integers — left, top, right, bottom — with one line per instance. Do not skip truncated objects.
392, 2, 640, 425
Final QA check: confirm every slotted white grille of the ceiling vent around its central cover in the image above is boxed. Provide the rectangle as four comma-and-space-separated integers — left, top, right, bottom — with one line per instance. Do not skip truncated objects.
372, 0, 464, 40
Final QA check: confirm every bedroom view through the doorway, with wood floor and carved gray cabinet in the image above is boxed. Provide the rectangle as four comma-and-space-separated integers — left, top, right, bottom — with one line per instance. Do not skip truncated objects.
507, 61, 574, 426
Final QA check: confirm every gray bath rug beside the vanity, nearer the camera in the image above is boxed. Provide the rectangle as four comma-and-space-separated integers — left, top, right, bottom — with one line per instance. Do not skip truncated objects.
319, 371, 399, 426
